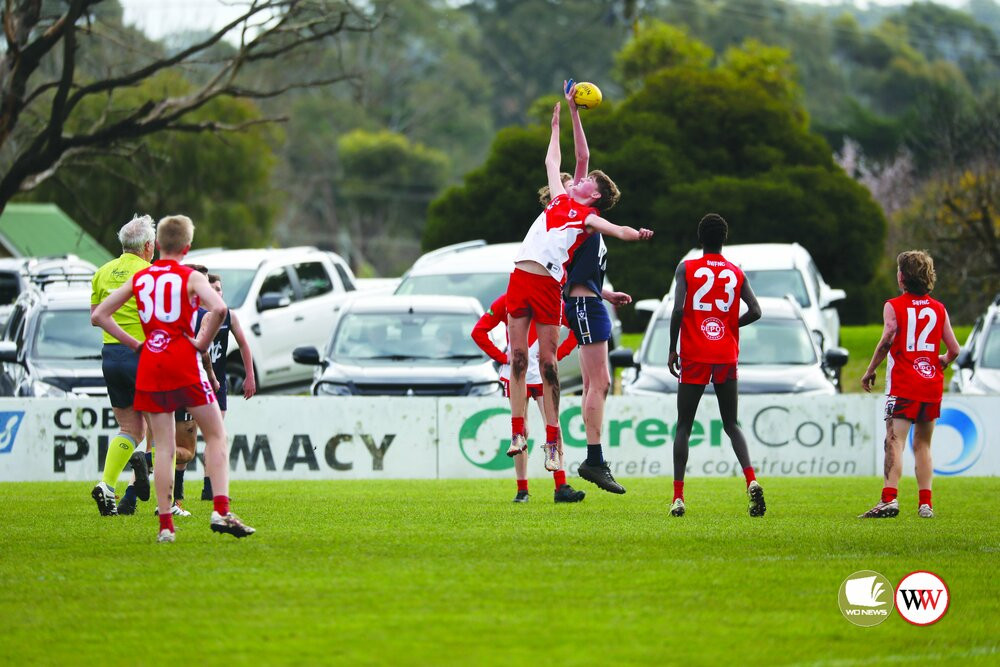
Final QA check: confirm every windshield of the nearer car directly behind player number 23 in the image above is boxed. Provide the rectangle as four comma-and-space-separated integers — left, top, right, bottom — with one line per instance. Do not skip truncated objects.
643, 317, 816, 366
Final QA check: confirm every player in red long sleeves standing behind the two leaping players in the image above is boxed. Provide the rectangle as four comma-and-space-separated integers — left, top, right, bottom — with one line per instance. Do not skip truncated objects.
472, 294, 587, 503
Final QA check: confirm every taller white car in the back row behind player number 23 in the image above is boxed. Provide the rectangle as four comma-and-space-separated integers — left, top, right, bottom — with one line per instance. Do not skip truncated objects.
668, 243, 847, 351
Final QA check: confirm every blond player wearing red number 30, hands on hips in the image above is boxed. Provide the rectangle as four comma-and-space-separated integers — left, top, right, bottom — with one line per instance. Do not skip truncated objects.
91, 215, 254, 542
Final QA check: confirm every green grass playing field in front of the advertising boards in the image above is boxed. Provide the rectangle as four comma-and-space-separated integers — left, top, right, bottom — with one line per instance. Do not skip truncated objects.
0, 478, 1000, 666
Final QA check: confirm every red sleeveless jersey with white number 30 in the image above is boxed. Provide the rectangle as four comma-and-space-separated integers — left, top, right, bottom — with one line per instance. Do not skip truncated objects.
132, 260, 208, 391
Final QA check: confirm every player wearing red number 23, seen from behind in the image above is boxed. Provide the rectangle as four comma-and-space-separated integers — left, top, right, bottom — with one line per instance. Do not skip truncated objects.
667, 213, 766, 516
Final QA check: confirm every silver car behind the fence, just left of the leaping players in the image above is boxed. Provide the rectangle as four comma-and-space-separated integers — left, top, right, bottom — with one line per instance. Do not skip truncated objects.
293, 295, 501, 396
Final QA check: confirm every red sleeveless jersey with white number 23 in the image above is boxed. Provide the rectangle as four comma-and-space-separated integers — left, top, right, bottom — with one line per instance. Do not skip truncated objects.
680, 254, 745, 364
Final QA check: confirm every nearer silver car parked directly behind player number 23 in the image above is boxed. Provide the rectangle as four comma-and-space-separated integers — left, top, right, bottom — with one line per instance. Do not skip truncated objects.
612, 297, 848, 395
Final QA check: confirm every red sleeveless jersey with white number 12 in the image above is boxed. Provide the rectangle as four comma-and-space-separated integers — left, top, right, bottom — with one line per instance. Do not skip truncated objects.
885, 292, 947, 403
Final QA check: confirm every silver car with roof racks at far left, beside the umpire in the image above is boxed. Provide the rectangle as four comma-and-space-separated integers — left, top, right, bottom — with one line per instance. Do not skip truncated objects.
0, 276, 108, 398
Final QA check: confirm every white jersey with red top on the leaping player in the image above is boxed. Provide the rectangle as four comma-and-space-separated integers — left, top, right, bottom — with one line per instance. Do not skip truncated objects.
514, 194, 597, 285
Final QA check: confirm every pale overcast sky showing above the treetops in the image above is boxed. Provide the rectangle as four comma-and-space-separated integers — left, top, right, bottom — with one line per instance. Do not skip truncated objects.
120, 0, 964, 39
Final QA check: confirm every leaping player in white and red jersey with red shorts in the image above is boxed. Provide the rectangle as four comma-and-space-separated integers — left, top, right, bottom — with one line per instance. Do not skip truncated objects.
507, 94, 653, 486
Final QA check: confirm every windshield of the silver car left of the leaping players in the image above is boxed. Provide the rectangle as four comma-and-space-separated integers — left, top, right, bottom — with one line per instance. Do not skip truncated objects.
330, 312, 486, 360
